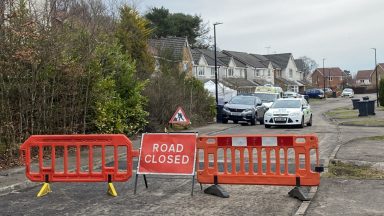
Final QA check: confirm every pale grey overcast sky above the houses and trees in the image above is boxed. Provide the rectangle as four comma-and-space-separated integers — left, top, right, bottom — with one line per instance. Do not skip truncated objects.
134, 0, 384, 73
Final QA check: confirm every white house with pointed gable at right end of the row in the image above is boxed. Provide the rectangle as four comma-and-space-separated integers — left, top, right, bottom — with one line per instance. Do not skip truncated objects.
263, 53, 304, 92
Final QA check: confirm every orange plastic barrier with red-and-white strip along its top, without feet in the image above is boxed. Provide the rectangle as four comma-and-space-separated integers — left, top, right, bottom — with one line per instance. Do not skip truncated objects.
197, 135, 320, 186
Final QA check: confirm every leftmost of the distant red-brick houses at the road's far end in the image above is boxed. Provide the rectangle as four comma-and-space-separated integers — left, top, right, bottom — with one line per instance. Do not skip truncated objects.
312, 67, 348, 89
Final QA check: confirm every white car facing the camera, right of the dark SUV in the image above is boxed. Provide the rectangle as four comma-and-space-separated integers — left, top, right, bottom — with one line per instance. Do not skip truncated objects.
264, 98, 312, 128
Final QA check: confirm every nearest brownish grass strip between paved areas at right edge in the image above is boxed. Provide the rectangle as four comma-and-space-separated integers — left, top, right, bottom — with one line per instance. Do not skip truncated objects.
325, 161, 384, 179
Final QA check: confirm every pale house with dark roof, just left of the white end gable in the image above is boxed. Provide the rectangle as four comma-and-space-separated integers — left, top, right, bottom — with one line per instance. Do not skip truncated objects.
222, 50, 274, 85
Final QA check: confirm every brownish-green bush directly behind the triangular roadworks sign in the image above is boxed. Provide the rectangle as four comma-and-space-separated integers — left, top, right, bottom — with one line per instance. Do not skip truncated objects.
144, 58, 215, 131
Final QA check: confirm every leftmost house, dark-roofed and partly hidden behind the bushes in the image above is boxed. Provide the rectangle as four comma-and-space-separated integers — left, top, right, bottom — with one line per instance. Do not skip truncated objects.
149, 37, 193, 76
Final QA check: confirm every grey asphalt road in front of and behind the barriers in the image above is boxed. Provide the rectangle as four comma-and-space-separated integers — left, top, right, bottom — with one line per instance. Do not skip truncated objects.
0, 98, 366, 215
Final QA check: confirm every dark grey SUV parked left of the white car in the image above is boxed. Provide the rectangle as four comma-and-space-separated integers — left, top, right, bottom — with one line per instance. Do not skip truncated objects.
222, 95, 267, 125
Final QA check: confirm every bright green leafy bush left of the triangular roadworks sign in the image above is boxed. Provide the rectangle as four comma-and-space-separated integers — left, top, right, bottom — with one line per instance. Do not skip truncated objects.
92, 43, 148, 135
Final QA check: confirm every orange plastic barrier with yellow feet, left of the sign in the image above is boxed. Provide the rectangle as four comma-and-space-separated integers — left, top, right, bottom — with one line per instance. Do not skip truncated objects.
20, 134, 139, 196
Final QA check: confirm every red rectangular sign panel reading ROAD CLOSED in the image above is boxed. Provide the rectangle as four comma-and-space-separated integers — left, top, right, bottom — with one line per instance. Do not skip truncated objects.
137, 134, 196, 175
